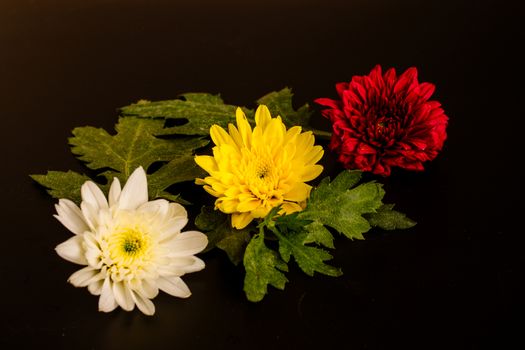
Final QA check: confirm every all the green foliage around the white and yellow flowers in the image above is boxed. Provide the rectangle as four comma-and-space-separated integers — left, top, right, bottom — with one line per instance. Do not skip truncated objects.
31, 88, 415, 302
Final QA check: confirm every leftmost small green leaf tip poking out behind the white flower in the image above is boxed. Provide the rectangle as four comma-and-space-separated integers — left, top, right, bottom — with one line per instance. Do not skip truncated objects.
30, 170, 95, 203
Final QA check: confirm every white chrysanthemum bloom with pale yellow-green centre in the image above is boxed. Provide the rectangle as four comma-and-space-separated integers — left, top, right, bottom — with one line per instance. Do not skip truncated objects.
55, 167, 208, 315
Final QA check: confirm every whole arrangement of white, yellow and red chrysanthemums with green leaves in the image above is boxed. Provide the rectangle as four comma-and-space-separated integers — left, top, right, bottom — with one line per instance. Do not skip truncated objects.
32, 66, 448, 315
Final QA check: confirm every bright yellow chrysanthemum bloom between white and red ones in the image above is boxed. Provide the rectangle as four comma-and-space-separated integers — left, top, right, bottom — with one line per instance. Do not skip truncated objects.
195, 105, 323, 229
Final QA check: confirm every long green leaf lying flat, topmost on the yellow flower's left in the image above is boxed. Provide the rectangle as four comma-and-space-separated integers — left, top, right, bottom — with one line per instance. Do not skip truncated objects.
121, 93, 253, 136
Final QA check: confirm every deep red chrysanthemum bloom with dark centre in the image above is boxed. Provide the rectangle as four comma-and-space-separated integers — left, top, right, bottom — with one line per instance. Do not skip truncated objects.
315, 65, 448, 176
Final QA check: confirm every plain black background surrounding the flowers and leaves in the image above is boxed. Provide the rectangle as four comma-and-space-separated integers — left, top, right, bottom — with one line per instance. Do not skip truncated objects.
0, 0, 525, 349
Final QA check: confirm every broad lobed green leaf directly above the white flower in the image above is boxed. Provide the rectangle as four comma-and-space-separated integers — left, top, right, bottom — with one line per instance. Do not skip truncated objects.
69, 117, 208, 198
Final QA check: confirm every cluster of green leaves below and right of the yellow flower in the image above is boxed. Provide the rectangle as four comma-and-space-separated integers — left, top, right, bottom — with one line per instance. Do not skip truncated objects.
235, 171, 414, 301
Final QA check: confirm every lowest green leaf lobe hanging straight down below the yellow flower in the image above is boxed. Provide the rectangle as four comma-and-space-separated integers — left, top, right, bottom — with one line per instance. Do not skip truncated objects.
243, 232, 288, 302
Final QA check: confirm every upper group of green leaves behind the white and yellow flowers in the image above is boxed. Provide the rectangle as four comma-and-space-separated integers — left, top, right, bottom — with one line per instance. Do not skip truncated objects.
33, 88, 329, 204
